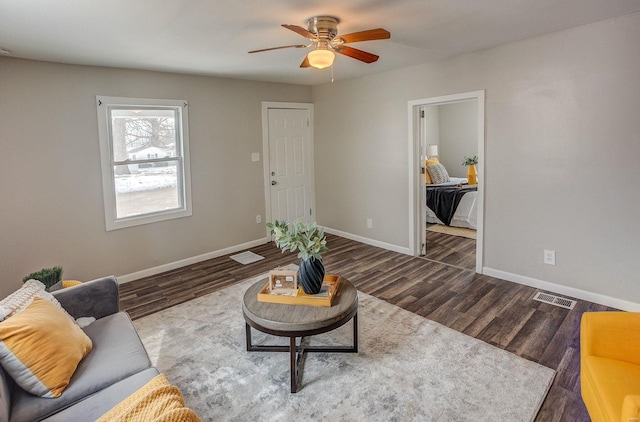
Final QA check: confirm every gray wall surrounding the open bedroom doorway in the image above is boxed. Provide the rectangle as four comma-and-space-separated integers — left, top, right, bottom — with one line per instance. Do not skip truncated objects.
313, 14, 640, 309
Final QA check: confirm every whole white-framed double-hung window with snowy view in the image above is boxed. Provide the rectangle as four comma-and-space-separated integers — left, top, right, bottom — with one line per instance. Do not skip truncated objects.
96, 96, 191, 231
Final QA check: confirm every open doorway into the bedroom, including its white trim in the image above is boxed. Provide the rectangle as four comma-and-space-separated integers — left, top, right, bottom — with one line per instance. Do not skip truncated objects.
409, 91, 484, 273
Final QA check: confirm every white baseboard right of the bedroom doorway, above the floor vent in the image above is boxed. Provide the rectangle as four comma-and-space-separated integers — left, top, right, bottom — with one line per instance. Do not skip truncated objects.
482, 267, 640, 312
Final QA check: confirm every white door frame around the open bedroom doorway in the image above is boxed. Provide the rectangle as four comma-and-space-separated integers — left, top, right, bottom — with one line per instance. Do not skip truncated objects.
408, 90, 485, 274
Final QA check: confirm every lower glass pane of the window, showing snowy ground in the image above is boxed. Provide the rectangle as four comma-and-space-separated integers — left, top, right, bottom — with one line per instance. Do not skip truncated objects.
114, 161, 183, 219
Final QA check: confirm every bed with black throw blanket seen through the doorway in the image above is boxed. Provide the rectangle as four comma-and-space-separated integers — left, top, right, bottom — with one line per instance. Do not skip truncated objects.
426, 177, 478, 230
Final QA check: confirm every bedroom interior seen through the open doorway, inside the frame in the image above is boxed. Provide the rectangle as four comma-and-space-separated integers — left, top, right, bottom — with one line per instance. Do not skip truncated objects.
420, 100, 478, 270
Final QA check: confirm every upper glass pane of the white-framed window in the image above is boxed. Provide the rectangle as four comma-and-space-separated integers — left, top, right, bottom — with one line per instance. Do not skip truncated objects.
111, 108, 177, 161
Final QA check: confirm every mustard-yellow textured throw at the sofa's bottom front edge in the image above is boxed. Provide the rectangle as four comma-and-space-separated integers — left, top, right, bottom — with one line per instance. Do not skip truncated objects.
96, 374, 200, 422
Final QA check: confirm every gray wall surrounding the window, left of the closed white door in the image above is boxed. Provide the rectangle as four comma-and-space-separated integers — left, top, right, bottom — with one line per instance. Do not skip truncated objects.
0, 58, 311, 297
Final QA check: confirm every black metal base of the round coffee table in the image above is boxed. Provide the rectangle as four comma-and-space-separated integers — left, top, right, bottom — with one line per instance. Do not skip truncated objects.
245, 312, 358, 393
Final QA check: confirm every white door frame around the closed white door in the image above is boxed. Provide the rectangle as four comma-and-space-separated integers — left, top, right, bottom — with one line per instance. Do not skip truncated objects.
262, 101, 316, 239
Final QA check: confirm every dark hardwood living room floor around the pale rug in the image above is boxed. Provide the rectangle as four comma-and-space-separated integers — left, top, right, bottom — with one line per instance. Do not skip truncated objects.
120, 235, 611, 422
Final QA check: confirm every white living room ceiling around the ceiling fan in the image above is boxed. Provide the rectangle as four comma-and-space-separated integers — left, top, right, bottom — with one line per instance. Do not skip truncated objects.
0, 0, 640, 85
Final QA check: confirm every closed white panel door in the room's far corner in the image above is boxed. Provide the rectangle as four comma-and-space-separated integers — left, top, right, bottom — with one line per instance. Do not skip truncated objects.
268, 108, 312, 222
